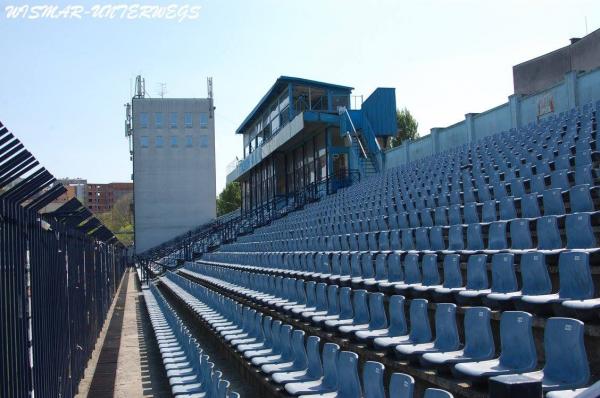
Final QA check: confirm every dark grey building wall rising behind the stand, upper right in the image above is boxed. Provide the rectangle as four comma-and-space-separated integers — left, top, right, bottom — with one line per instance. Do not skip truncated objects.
513, 29, 600, 95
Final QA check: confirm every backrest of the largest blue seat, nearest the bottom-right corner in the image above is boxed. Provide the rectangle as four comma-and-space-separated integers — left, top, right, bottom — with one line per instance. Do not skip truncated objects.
544, 318, 590, 388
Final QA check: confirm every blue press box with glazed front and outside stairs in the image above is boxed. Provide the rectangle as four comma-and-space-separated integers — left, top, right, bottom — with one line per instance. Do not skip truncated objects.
227, 76, 397, 213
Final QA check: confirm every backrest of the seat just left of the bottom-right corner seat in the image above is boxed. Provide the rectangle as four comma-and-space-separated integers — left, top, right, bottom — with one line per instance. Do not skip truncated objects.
500, 311, 537, 372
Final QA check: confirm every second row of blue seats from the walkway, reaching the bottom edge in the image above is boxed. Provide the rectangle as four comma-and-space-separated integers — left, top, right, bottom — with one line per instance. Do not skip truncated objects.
161, 273, 452, 398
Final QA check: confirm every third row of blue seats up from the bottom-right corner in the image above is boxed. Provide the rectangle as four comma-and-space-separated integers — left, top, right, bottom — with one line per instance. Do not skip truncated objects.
222, 212, 600, 253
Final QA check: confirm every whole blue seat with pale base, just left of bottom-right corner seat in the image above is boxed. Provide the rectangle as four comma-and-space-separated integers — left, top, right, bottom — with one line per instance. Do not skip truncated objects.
454, 311, 537, 381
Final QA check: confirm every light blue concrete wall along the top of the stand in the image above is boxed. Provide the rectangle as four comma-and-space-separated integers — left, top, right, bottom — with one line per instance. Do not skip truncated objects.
385, 68, 600, 168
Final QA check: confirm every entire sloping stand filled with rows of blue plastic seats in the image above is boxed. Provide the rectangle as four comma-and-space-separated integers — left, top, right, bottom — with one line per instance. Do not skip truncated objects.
145, 102, 600, 398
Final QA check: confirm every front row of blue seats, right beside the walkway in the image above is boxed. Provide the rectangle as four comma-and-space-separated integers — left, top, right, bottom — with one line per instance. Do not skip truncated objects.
144, 284, 240, 398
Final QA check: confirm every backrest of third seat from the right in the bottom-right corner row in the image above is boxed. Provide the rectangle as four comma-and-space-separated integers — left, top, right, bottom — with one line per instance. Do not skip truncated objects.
464, 307, 496, 360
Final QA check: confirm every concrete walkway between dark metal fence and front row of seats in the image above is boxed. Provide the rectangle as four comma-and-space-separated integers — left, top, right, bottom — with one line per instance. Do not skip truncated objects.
77, 270, 171, 398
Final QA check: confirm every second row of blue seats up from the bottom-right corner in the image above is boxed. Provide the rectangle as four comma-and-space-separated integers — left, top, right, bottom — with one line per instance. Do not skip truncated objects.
198, 251, 600, 319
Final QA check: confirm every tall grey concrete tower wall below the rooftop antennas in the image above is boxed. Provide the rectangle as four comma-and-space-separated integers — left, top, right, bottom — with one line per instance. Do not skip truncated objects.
132, 98, 216, 253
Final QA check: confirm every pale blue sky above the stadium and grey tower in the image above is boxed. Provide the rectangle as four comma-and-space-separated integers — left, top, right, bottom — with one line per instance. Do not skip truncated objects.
0, 0, 600, 191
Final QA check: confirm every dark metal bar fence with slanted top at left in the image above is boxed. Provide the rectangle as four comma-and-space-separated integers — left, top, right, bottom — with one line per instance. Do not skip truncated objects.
0, 123, 126, 397
